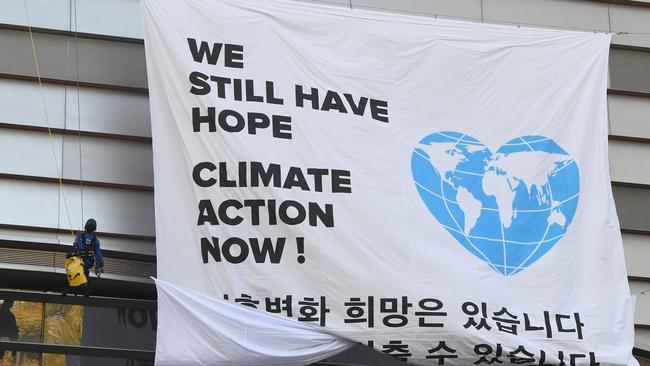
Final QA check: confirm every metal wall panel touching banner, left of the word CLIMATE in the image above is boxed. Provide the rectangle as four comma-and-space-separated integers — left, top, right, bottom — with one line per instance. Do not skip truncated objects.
63, 136, 153, 187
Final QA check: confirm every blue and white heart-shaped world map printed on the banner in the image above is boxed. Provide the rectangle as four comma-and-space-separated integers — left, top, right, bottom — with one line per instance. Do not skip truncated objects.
411, 131, 580, 276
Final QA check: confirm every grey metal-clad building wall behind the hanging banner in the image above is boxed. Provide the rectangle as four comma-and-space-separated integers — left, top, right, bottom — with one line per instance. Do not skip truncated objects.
0, 0, 650, 360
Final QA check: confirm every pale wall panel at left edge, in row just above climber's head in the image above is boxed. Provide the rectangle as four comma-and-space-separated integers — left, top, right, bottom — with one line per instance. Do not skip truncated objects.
0, 179, 59, 228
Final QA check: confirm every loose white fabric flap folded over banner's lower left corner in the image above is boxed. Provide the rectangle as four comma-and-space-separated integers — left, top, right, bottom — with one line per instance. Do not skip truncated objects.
156, 279, 352, 366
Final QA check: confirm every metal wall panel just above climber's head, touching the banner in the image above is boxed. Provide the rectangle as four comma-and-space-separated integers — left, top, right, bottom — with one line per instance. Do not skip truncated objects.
57, 185, 156, 236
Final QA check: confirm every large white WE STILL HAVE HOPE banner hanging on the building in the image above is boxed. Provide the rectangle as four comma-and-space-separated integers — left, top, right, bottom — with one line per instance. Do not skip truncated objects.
142, 0, 636, 365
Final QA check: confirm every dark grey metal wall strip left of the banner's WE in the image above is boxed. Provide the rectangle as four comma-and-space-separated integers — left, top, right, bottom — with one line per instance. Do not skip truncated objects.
0, 29, 147, 87
